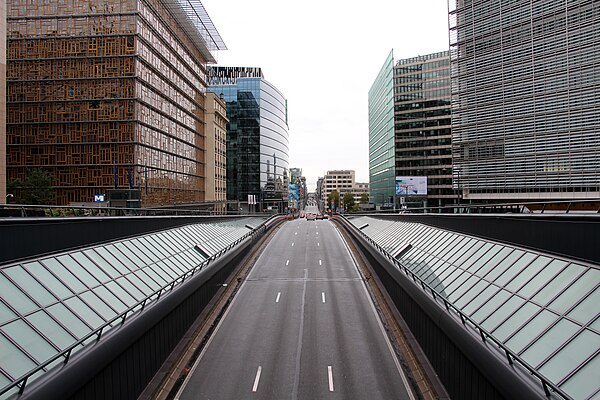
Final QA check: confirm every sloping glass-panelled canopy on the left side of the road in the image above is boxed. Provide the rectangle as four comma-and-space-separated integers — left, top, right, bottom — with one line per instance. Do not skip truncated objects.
0, 217, 266, 399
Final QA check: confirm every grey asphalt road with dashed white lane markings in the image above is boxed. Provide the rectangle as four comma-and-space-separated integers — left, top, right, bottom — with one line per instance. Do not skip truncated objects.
176, 219, 412, 400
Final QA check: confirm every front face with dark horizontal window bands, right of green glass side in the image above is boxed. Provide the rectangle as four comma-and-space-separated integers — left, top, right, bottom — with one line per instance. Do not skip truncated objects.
394, 51, 457, 206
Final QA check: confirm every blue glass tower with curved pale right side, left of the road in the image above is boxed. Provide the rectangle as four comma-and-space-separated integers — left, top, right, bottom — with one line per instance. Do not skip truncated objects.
209, 66, 289, 206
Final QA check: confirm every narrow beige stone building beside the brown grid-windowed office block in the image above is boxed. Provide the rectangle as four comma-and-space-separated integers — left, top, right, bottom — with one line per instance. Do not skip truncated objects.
205, 92, 229, 209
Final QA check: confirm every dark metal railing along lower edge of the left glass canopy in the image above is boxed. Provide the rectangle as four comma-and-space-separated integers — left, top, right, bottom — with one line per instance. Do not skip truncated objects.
0, 216, 277, 396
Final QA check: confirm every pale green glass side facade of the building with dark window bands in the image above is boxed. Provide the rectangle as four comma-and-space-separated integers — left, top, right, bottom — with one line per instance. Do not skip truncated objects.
369, 52, 396, 206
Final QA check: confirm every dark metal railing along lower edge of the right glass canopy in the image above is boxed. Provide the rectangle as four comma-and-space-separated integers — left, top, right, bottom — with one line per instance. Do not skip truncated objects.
339, 215, 573, 400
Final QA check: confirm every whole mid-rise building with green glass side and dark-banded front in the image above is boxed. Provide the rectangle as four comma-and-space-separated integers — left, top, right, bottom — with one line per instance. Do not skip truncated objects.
369, 52, 458, 207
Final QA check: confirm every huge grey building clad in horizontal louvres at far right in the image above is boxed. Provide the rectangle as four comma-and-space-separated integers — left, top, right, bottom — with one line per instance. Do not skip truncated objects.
449, 0, 600, 200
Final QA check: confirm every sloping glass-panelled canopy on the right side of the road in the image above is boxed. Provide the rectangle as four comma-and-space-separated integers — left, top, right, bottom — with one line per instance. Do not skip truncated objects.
350, 217, 600, 399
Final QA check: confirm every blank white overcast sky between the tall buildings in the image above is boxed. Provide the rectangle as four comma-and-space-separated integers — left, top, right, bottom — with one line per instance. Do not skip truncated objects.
201, 0, 448, 191
